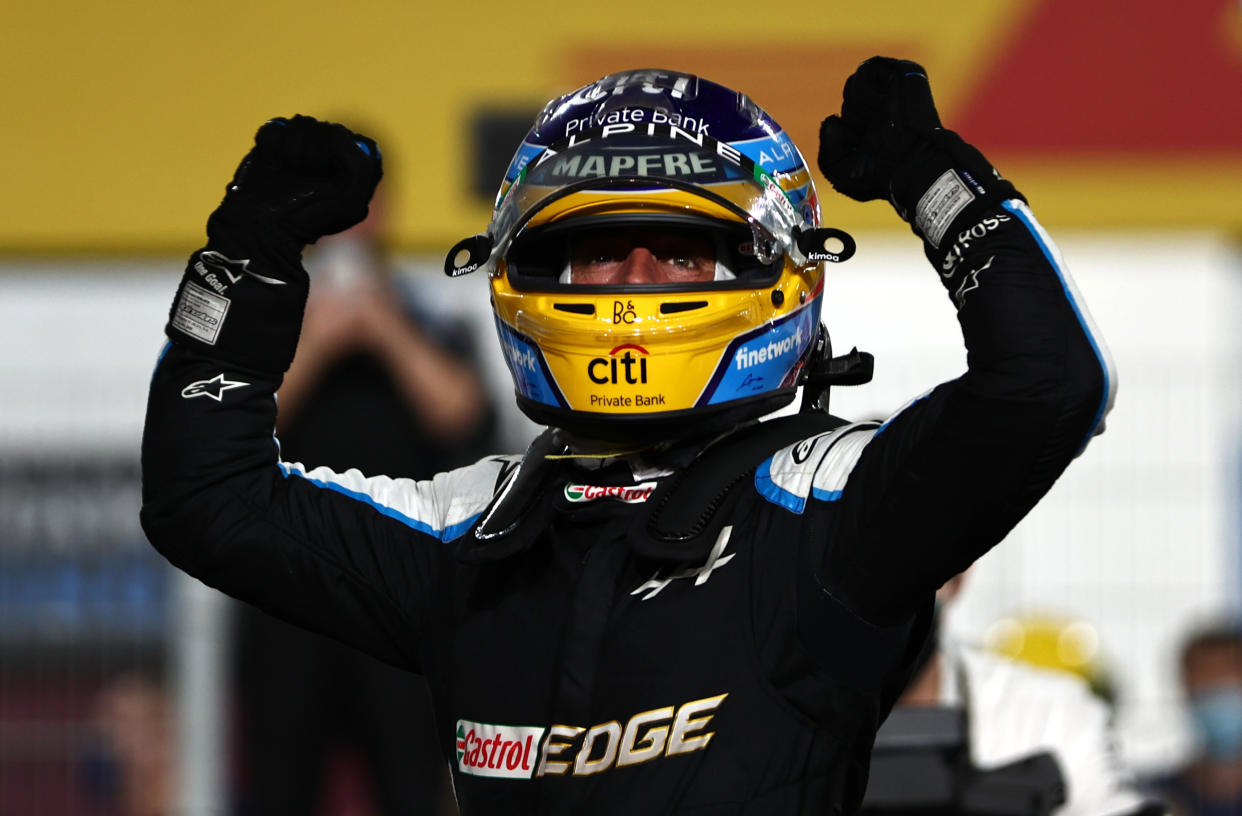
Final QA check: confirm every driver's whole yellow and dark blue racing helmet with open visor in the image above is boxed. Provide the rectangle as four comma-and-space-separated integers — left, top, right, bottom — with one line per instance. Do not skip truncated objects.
445, 70, 854, 441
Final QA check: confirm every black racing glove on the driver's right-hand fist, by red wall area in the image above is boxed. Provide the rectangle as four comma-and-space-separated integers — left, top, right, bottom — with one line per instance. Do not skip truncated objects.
818, 57, 1022, 255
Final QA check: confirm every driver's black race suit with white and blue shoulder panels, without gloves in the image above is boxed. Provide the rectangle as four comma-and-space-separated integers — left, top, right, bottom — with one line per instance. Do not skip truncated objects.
143, 201, 1112, 816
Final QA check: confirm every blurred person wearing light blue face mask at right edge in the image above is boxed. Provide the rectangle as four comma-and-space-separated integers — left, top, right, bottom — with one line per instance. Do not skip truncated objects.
1154, 622, 1242, 816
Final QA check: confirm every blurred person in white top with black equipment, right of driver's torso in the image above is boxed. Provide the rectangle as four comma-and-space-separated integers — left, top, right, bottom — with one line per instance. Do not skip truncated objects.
864, 573, 1165, 816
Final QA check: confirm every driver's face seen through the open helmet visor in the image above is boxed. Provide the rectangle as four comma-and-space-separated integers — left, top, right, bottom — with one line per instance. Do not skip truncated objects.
569, 227, 715, 283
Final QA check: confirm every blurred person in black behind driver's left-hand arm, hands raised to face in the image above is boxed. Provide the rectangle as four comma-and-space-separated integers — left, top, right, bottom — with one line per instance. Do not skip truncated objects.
237, 188, 494, 816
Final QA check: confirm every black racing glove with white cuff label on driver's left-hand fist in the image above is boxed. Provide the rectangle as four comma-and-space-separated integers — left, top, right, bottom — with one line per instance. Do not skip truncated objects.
165, 116, 383, 374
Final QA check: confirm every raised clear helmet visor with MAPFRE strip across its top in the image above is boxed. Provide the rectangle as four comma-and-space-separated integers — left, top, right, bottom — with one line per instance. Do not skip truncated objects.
479, 122, 815, 288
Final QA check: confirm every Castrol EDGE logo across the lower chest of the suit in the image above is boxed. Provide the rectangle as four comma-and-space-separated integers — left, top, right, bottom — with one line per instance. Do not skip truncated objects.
457, 694, 728, 779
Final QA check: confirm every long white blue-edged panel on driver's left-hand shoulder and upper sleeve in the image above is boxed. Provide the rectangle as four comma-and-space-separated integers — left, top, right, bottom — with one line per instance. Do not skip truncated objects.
279, 456, 522, 542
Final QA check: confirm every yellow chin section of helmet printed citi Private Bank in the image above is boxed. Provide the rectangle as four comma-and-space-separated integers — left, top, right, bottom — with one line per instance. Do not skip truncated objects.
492, 254, 822, 415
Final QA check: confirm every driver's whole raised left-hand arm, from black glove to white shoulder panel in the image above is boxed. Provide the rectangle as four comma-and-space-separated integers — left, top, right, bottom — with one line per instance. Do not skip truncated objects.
142, 117, 501, 669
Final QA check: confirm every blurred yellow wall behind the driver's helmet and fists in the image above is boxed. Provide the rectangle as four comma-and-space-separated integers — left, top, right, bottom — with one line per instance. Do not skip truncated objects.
0, 0, 1242, 253
